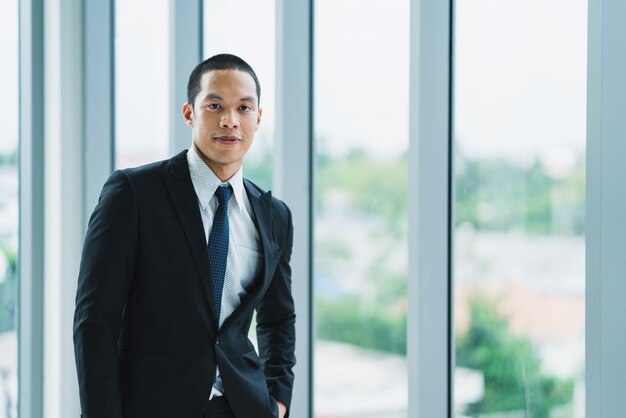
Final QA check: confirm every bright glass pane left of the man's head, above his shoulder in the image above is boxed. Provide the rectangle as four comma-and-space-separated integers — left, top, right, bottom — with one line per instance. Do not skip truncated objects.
115, 0, 168, 168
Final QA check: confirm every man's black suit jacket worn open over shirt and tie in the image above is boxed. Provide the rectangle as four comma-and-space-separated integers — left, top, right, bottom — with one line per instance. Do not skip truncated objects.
74, 152, 295, 418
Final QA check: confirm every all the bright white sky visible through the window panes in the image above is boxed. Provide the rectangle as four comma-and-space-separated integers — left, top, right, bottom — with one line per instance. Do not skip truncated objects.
0, 0, 587, 163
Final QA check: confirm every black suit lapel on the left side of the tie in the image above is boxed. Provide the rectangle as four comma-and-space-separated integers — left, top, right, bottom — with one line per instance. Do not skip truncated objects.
161, 151, 217, 331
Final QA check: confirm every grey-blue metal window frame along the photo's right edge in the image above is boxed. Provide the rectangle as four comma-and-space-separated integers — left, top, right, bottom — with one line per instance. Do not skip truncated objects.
585, 0, 626, 417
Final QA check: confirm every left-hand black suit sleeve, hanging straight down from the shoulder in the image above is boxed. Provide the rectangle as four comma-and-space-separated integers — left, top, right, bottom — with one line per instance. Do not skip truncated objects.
74, 171, 138, 418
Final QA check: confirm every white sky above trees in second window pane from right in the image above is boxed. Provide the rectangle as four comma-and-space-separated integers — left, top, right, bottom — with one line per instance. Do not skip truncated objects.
314, 0, 409, 157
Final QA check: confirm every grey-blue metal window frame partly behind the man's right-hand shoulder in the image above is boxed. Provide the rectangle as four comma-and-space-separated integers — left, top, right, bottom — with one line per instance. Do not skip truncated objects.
273, 0, 315, 417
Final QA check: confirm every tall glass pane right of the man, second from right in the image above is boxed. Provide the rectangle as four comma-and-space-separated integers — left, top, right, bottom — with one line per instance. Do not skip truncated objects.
314, 0, 410, 418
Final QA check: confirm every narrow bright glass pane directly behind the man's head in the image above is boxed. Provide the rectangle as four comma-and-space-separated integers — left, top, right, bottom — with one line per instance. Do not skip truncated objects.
204, 0, 276, 190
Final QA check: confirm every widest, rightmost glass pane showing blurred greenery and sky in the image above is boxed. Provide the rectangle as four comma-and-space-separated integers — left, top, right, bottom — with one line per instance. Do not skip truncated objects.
454, 0, 587, 418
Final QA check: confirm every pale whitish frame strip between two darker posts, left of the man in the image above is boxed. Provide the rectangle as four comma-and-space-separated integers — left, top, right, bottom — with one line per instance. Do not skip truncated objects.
42, 0, 85, 418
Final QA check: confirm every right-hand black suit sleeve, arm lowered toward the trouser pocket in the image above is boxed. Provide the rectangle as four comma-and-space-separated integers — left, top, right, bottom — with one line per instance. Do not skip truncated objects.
257, 202, 296, 415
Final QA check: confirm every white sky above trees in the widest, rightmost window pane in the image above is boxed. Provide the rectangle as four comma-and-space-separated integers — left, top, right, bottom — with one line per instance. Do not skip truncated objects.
454, 0, 587, 159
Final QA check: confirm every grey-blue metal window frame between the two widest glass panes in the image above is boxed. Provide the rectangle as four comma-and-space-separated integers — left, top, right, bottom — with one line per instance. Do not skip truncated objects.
407, 0, 453, 417
